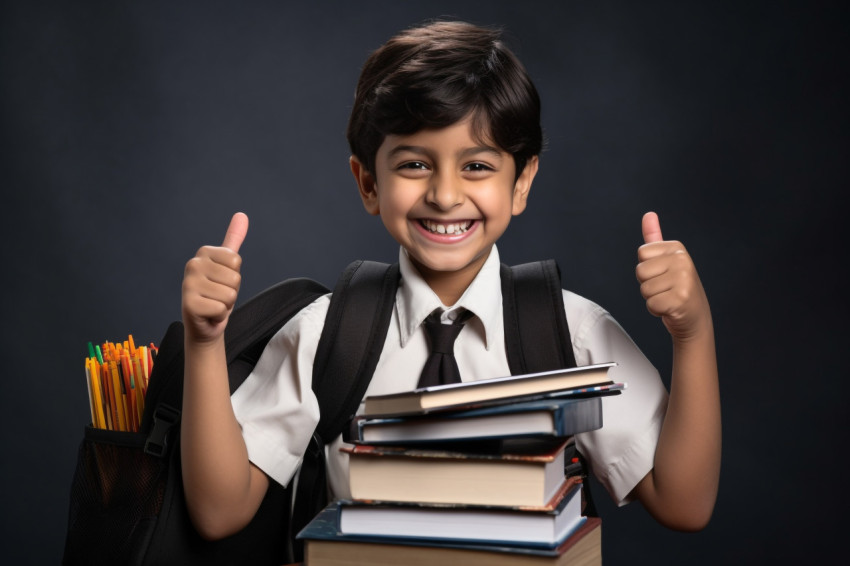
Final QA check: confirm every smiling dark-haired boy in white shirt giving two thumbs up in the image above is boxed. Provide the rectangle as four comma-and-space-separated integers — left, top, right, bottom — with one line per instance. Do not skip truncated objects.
181, 22, 720, 538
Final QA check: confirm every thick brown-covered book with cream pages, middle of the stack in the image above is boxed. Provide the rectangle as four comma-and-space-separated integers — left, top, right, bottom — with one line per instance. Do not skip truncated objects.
342, 438, 573, 506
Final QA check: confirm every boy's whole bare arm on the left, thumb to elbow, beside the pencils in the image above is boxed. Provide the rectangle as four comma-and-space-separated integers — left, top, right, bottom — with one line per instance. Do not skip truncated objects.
180, 213, 268, 539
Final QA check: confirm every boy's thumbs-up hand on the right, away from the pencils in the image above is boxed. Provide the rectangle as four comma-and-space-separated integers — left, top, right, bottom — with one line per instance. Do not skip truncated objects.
635, 212, 711, 341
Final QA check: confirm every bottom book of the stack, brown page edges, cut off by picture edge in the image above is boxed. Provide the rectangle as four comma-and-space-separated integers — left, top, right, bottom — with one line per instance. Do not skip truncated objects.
299, 512, 602, 566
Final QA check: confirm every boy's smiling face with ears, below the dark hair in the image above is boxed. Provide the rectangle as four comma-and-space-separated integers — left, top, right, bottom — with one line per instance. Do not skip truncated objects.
351, 120, 537, 286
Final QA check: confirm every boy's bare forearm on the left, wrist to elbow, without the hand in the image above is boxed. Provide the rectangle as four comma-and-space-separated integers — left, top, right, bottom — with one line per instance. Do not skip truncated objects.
181, 340, 267, 538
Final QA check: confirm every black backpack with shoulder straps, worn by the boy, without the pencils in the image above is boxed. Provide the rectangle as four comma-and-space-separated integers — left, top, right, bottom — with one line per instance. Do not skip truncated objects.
62, 260, 594, 566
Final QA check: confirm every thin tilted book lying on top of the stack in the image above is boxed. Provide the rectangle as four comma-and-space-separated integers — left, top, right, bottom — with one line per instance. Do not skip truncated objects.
363, 363, 616, 417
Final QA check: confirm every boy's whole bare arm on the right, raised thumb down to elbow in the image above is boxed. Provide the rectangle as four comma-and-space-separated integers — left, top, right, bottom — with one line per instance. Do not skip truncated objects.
633, 212, 721, 530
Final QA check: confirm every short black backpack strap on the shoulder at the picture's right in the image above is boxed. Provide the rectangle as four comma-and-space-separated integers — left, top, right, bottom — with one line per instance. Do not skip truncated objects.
501, 259, 576, 375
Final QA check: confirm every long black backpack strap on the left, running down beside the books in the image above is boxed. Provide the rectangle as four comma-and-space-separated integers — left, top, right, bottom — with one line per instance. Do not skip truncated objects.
290, 261, 399, 562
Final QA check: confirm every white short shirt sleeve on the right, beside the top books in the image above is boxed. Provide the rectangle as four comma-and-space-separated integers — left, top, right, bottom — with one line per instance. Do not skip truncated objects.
564, 291, 668, 505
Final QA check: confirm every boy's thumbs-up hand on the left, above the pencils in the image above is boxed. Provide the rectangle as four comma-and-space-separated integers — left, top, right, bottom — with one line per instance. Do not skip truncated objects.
183, 212, 248, 343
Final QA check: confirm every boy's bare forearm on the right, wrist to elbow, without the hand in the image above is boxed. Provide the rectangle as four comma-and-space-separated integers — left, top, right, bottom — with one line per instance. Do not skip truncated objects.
637, 315, 721, 530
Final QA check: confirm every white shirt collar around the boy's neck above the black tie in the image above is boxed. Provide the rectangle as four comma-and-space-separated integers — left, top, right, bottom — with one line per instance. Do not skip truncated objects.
396, 245, 505, 350
